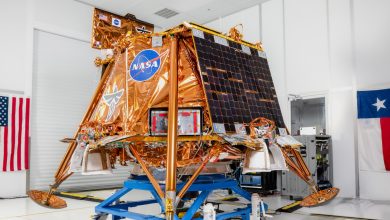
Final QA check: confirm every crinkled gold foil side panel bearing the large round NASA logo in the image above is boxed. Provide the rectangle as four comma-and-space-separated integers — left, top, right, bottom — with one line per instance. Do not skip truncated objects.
85, 34, 211, 135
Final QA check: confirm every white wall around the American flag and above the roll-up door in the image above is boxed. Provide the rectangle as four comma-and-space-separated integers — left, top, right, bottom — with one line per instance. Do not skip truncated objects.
0, 0, 93, 197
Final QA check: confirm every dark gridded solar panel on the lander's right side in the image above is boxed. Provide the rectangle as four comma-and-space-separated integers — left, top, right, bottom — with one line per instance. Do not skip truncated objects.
193, 30, 285, 132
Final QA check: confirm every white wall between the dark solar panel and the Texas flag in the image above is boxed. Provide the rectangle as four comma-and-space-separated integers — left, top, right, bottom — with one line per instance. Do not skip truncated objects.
262, 0, 356, 197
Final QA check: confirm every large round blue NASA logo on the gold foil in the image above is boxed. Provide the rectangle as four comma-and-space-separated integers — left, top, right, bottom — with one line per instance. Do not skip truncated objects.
129, 49, 161, 82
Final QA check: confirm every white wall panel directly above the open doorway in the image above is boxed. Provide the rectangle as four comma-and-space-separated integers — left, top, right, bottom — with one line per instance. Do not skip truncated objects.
284, 0, 329, 93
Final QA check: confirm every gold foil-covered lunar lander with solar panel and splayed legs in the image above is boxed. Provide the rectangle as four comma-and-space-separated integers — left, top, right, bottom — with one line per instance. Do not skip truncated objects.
29, 8, 338, 219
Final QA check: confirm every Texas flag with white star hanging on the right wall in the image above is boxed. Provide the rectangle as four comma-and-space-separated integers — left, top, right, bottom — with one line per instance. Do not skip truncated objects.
357, 89, 390, 172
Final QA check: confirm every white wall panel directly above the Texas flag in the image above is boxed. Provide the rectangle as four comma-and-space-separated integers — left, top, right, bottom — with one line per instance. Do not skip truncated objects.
354, 0, 390, 88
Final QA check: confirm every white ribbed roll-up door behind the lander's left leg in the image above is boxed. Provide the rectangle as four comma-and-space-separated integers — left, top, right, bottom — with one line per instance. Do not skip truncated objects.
30, 31, 129, 189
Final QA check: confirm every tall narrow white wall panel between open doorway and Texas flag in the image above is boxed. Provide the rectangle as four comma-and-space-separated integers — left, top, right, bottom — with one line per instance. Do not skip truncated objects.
328, 0, 357, 197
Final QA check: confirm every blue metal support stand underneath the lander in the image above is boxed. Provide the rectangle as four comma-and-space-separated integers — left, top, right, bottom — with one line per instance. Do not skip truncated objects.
95, 175, 268, 220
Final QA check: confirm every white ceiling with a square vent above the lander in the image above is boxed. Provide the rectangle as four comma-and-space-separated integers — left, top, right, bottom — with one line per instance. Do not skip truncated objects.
75, 0, 268, 29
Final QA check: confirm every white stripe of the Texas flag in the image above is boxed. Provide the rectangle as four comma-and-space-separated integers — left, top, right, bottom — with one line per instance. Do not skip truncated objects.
358, 118, 386, 172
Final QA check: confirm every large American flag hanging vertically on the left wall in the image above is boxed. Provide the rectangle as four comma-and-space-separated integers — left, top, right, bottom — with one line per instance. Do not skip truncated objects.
0, 96, 30, 172
